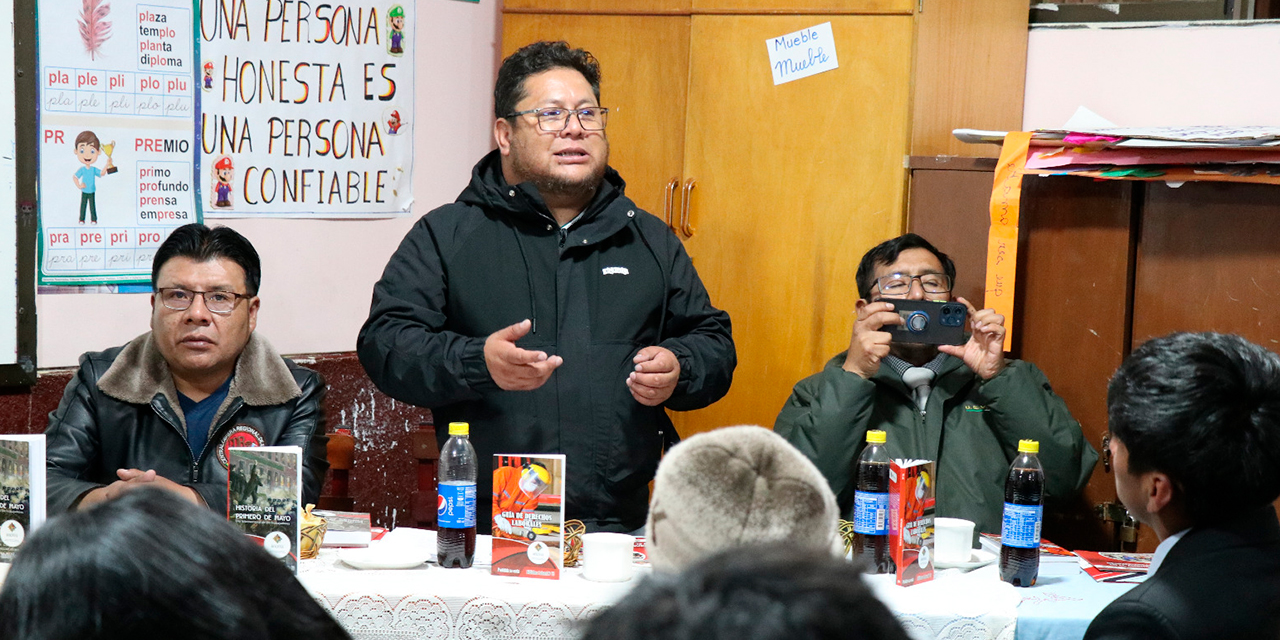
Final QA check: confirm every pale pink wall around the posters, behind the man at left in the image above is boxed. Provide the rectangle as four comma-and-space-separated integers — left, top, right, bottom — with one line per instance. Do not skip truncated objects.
36, 0, 502, 369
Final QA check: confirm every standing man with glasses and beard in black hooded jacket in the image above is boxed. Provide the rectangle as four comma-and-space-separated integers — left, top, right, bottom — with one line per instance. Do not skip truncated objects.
357, 42, 737, 531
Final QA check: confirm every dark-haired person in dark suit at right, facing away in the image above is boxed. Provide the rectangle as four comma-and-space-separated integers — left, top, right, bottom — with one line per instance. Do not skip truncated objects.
1085, 333, 1280, 640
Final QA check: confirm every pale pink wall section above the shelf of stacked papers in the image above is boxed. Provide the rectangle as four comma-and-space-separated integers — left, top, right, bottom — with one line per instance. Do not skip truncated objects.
1023, 22, 1280, 129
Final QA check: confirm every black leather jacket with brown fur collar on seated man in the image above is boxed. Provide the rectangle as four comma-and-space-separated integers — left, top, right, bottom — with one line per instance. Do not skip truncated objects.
45, 333, 329, 516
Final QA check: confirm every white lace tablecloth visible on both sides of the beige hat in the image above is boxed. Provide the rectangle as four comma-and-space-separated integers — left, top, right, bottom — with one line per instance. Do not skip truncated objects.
298, 535, 1020, 640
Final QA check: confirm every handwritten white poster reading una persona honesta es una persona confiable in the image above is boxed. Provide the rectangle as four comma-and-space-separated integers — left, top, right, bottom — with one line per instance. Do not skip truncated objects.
198, 0, 414, 218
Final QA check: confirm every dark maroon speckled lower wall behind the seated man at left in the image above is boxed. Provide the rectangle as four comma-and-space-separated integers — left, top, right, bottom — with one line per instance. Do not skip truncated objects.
0, 353, 431, 527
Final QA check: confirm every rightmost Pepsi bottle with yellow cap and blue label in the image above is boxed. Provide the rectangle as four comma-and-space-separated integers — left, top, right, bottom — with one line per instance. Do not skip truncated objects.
1000, 440, 1044, 586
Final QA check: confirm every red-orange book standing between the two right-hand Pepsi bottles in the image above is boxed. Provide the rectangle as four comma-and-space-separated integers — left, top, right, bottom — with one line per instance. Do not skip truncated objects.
888, 460, 934, 586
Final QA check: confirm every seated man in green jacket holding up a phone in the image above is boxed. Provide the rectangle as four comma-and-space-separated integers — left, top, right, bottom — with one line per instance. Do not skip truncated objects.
773, 233, 1098, 532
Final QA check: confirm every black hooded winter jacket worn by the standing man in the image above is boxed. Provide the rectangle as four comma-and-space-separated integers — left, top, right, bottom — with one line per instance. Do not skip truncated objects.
358, 151, 737, 531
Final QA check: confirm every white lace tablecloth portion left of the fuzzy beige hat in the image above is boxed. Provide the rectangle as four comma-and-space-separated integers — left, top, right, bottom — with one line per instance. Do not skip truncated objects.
298, 536, 648, 640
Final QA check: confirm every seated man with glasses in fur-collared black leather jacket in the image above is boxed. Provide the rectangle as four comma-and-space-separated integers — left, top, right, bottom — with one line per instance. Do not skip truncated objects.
45, 224, 329, 516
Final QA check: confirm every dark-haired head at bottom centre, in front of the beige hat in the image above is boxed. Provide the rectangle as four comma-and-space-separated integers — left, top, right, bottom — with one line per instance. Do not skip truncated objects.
582, 543, 908, 640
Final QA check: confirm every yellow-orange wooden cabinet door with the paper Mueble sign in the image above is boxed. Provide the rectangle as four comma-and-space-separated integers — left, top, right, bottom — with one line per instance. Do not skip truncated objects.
673, 15, 911, 434
